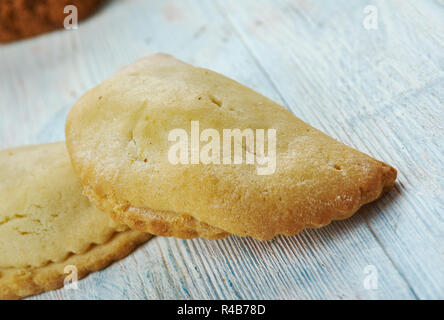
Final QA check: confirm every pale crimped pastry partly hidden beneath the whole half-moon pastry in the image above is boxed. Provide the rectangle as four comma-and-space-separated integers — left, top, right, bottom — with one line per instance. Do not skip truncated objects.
0, 142, 151, 299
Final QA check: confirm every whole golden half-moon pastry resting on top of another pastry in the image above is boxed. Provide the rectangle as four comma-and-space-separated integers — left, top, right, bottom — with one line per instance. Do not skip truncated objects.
66, 54, 396, 240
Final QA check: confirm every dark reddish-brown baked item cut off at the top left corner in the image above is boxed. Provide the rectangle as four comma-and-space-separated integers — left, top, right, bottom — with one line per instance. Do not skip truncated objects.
0, 0, 103, 43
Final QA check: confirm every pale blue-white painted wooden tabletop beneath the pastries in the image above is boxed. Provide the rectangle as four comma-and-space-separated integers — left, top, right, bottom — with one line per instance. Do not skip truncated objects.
0, 0, 444, 299
